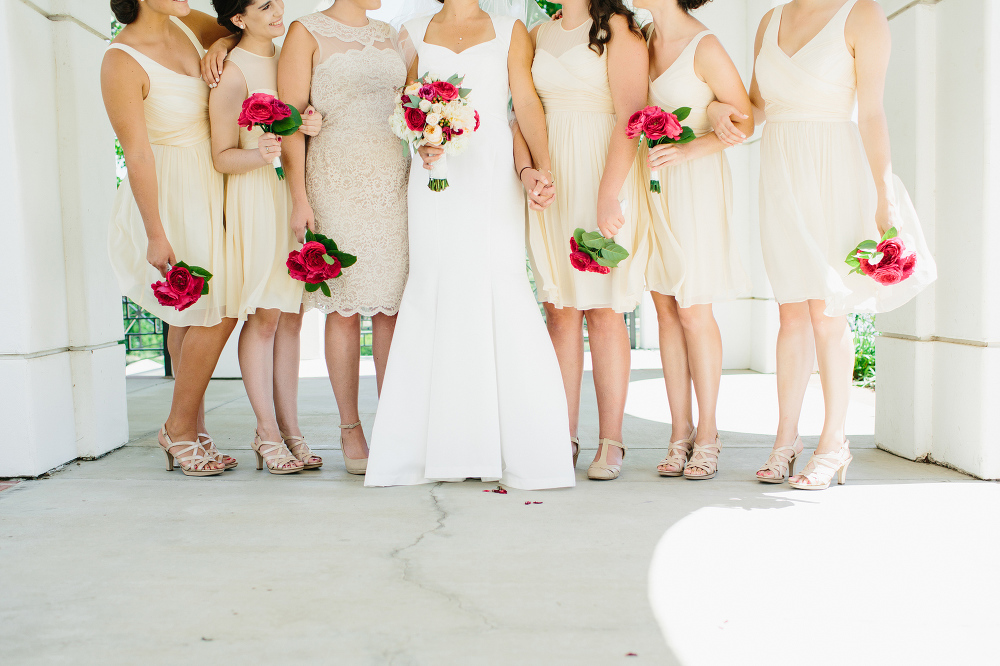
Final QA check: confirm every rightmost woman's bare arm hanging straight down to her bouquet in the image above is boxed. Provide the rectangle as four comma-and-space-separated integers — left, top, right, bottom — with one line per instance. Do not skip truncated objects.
845, 0, 894, 234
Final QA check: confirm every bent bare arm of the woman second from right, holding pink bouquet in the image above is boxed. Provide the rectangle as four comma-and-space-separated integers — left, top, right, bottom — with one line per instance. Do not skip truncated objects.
649, 35, 754, 169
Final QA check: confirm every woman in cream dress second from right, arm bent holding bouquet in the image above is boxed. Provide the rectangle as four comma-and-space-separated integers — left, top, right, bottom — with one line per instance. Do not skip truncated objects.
636, 0, 753, 479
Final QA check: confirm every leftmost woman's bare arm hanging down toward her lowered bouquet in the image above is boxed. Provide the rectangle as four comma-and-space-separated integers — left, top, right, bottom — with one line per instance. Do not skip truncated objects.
101, 49, 177, 275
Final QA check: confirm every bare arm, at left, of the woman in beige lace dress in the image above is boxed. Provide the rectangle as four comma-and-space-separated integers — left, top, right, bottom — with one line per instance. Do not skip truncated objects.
278, 21, 319, 243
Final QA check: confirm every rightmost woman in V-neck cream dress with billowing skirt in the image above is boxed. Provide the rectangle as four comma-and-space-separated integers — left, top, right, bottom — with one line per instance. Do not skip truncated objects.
712, 0, 935, 490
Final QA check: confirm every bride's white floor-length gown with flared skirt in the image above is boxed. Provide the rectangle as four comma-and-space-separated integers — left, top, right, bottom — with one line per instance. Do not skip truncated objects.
365, 15, 575, 490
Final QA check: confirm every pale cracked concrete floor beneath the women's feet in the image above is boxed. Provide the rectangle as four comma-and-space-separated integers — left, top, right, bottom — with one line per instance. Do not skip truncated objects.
0, 370, 988, 666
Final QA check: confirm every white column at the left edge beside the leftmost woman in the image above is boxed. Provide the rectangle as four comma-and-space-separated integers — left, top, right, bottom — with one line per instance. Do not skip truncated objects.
0, 0, 128, 476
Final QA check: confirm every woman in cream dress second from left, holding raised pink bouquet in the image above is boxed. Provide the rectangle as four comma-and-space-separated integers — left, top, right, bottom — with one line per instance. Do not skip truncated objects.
209, 0, 323, 474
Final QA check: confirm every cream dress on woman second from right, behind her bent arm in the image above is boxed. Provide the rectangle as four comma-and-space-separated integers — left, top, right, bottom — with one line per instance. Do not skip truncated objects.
639, 30, 750, 308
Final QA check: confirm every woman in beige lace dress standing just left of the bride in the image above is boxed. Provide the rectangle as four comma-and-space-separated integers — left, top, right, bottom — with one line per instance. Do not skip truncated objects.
278, 0, 410, 474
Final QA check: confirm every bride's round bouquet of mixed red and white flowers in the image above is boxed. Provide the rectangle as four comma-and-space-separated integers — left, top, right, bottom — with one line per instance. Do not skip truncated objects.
389, 74, 479, 192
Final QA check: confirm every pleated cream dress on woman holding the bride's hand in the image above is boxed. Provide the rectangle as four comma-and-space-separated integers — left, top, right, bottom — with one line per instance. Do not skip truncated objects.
528, 19, 649, 312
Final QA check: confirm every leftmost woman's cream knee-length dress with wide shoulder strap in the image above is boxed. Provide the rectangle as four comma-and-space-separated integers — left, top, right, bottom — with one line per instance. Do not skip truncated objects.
108, 18, 226, 326
